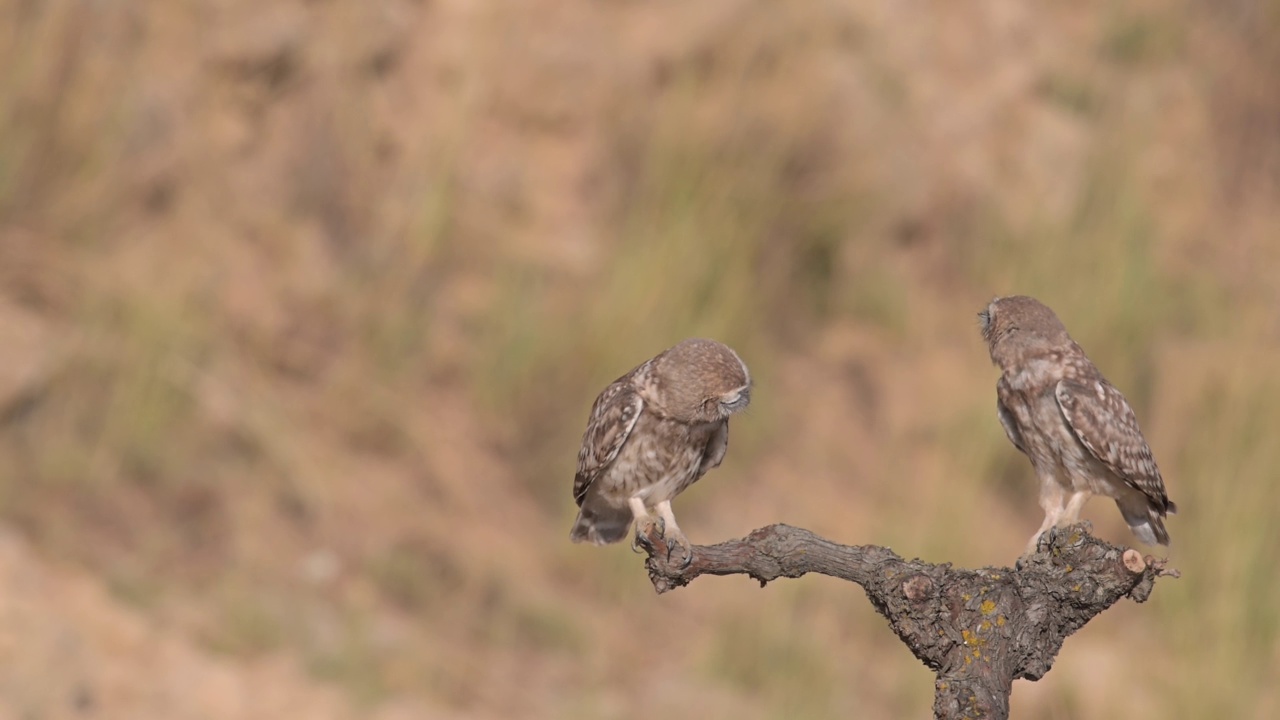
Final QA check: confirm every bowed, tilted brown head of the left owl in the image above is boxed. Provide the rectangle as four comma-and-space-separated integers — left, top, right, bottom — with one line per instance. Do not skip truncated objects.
654, 338, 751, 423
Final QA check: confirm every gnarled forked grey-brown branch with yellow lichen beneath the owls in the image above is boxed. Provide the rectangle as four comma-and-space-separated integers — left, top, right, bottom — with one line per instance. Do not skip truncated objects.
639, 523, 1178, 720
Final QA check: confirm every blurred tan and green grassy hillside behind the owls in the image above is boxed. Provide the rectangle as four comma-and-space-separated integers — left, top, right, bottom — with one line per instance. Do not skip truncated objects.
0, 0, 1280, 720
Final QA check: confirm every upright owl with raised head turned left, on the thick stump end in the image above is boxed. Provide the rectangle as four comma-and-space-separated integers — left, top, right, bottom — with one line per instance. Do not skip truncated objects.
978, 295, 1176, 555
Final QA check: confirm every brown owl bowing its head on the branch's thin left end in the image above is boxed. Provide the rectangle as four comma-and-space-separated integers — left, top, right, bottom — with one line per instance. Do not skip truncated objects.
570, 338, 751, 565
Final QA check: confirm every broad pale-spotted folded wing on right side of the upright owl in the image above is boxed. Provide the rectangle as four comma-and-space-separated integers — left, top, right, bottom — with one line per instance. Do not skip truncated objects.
1053, 378, 1176, 512
